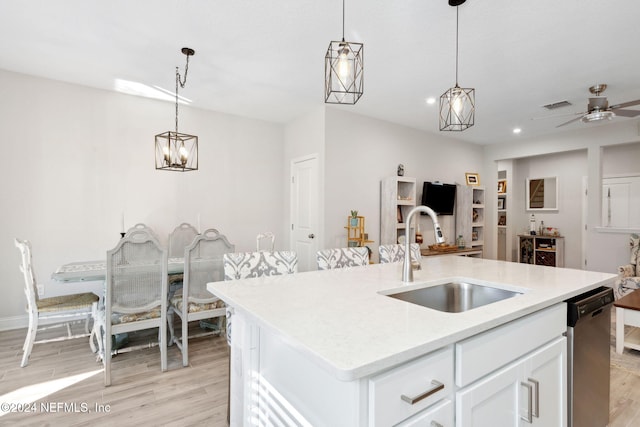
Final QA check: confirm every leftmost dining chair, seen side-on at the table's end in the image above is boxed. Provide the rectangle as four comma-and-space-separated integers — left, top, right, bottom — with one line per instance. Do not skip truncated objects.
14, 239, 99, 368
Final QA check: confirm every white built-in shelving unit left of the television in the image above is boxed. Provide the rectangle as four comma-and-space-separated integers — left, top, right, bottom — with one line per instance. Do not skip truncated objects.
380, 176, 416, 245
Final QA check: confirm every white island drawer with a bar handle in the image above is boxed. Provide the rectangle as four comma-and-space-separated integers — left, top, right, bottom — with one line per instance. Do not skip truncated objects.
369, 346, 453, 426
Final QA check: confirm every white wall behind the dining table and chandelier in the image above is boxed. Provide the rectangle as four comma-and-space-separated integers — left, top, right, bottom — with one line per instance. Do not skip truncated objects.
0, 71, 286, 329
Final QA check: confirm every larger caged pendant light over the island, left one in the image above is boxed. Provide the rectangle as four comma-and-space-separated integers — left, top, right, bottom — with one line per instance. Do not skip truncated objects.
324, 0, 364, 104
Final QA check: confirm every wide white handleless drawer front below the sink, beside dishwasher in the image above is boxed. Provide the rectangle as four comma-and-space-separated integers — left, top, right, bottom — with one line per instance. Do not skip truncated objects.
455, 303, 567, 387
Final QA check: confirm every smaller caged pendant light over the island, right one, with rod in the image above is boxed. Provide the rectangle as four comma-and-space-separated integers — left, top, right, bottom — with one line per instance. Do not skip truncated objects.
440, 0, 476, 131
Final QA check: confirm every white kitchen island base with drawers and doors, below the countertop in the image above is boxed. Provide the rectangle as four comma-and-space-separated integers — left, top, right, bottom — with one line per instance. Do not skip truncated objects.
231, 303, 567, 427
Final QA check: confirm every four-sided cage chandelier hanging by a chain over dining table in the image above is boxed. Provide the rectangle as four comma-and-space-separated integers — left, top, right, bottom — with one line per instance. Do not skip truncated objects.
156, 47, 198, 172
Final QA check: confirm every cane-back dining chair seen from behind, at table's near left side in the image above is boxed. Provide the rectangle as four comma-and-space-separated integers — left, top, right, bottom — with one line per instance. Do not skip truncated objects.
101, 230, 167, 386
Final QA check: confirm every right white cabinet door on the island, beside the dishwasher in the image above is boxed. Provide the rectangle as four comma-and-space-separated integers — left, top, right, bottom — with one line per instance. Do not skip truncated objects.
520, 337, 567, 427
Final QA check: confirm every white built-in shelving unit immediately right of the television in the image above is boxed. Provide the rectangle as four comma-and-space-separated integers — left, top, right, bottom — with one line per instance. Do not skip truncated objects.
456, 184, 485, 258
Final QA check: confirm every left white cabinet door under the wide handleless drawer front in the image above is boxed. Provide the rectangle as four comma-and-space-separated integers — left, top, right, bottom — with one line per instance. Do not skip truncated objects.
456, 364, 522, 427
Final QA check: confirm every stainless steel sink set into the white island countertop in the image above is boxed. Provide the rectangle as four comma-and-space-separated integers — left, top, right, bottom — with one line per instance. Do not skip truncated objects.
387, 281, 522, 313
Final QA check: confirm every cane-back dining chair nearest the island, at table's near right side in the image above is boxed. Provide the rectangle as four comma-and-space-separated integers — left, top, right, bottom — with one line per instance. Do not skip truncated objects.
167, 229, 235, 366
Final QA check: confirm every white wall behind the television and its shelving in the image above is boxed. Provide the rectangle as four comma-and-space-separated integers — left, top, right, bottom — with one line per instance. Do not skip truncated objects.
324, 107, 482, 260
